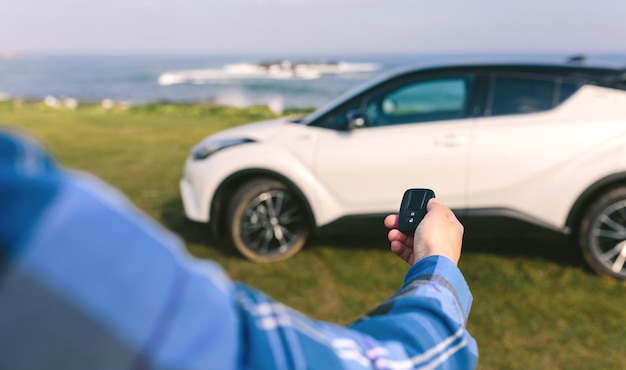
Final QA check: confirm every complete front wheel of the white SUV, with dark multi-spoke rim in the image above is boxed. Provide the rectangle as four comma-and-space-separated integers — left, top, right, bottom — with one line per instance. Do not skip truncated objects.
227, 179, 311, 262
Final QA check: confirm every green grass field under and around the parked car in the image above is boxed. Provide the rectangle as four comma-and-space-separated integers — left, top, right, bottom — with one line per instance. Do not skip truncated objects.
0, 102, 626, 369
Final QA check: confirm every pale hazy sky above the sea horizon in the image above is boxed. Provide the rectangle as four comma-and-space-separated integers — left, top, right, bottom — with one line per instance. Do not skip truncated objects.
0, 0, 626, 54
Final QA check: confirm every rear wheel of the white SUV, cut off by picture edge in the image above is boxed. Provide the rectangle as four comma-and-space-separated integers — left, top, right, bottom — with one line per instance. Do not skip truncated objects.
578, 187, 626, 280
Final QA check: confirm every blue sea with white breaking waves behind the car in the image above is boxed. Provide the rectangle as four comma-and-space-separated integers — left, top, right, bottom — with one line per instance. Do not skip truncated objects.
0, 53, 626, 109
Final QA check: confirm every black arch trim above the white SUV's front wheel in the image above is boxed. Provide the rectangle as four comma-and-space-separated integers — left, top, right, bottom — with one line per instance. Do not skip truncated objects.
209, 168, 315, 238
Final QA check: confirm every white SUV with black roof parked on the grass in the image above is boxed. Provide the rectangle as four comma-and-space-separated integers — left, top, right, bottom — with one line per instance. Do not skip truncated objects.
180, 64, 626, 279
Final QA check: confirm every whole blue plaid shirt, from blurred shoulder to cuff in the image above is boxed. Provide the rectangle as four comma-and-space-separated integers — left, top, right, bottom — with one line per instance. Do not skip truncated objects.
0, 131, 478, 370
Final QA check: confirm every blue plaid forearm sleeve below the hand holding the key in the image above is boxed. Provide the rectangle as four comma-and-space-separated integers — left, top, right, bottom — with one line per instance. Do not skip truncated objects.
238, 257, 478, 369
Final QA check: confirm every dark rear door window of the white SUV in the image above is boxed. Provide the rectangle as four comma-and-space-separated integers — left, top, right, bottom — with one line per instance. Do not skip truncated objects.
490, 77, 555, 116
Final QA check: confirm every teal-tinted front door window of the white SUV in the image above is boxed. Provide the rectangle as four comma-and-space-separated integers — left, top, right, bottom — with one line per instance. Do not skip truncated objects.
364, 77, 469, 126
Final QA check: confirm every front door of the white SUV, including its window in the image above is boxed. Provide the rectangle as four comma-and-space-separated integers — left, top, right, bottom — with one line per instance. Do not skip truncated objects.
315, 74, 473, 214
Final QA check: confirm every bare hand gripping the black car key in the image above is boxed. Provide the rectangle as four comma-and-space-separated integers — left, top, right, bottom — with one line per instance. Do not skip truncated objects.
385, 198, 463, 265
